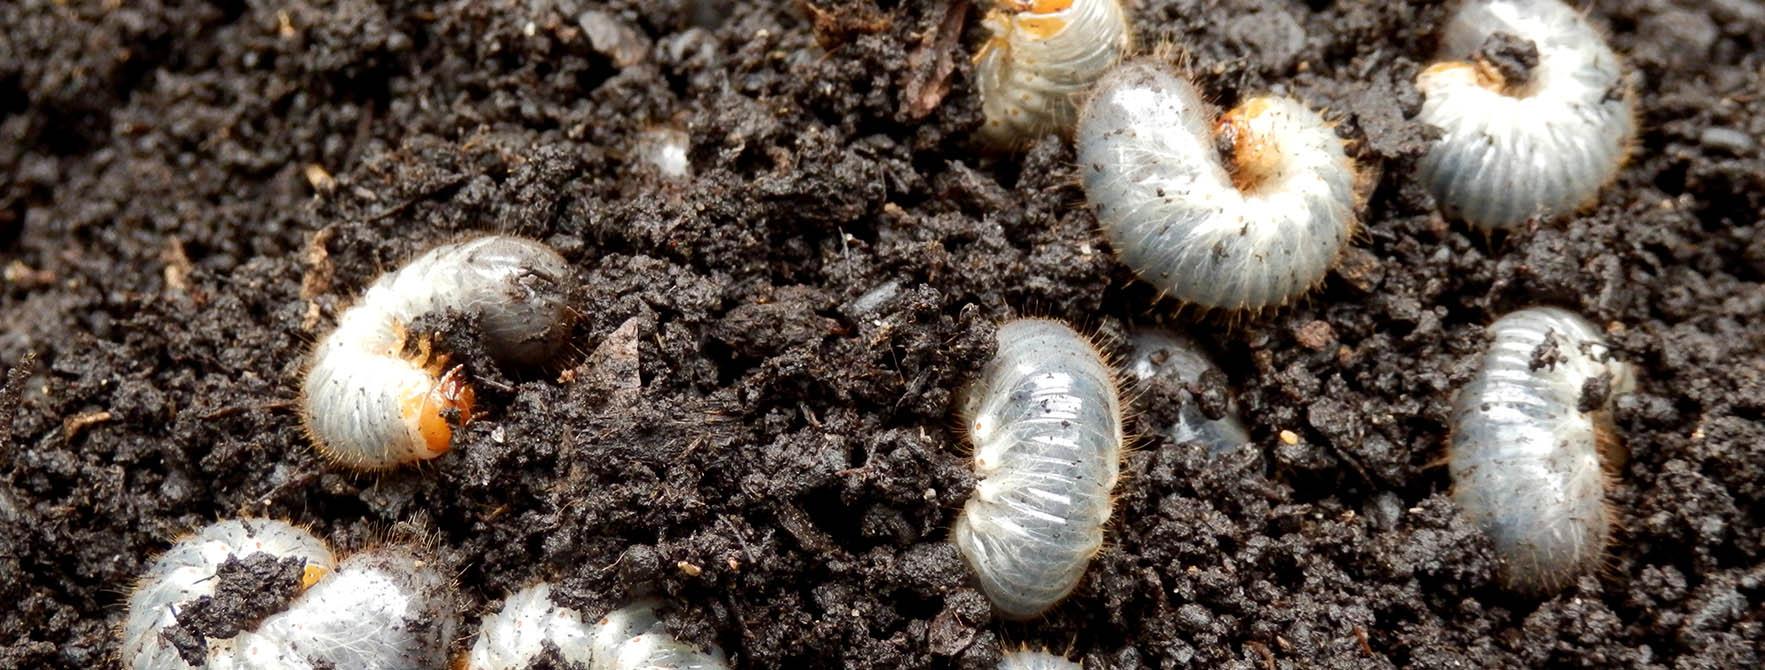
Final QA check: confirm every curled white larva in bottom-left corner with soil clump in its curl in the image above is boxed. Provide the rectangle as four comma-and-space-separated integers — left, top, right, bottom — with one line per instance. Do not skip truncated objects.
122, 518, 457, 670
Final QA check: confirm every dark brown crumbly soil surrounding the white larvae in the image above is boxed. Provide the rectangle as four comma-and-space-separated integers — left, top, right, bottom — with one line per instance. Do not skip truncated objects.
0, 0, 1765, 668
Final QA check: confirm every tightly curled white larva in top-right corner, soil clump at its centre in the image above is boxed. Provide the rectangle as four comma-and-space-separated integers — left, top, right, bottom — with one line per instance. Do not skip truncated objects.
1416, 0, 1636, 229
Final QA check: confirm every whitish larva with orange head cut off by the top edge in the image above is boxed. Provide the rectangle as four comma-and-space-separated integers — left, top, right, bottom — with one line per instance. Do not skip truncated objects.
974, 0, 1133, 146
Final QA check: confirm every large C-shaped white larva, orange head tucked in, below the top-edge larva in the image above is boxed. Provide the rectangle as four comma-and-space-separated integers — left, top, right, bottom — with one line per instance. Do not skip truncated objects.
1073, 62, 1356, 309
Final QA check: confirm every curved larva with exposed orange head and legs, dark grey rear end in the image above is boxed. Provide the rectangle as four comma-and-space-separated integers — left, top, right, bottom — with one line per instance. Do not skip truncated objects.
300, 235, 570, 469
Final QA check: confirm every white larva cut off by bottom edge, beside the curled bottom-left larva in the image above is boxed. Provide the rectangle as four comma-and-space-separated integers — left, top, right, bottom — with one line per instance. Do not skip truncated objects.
464, 582, 727, 670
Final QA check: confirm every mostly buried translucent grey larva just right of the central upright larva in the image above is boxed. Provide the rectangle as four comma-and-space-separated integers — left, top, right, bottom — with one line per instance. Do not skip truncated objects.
1128, 330, 1250, 455
